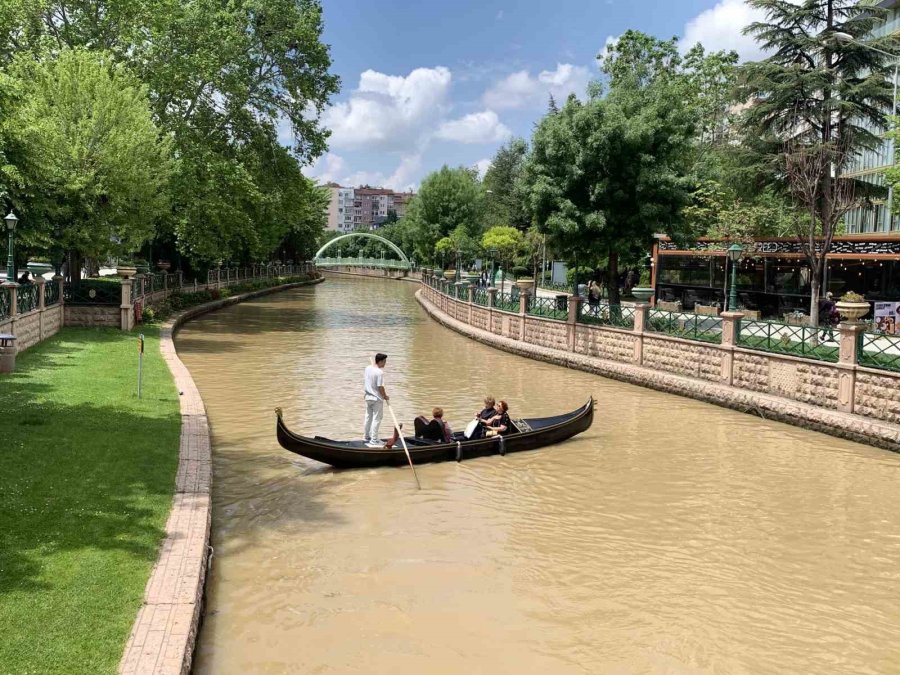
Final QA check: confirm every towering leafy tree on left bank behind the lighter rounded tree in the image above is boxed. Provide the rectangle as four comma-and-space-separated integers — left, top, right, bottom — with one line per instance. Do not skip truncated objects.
0, 0, 339, 261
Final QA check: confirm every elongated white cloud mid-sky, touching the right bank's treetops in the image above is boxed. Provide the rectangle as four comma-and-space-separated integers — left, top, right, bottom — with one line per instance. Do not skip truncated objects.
482, 63, 591, 110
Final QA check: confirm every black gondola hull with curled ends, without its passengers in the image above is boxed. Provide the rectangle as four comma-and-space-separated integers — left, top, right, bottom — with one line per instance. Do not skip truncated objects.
275, 397, 594, 469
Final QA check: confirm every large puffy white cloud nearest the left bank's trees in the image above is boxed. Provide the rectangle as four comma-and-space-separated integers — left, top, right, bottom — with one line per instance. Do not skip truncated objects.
323, 66, 451, 152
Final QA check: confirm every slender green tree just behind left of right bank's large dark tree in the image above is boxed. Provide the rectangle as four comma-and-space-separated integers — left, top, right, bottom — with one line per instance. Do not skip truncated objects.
482, 138, 531, 230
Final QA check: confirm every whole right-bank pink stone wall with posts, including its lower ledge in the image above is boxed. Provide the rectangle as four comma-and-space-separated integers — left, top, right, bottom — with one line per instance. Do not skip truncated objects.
417, 284, 900, 450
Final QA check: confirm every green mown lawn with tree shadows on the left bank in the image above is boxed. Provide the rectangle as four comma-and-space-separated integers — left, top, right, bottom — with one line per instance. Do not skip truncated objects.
0, 326, 181, 674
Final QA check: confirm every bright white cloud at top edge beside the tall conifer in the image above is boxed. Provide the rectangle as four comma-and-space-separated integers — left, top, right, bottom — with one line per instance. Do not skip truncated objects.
681, 0, 765, 61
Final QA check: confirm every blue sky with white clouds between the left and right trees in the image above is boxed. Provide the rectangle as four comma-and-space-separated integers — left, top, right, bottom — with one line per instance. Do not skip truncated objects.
305, 0, 759, 189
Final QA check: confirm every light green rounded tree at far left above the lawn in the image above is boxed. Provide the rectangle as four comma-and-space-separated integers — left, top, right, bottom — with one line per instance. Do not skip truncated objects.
0, 49, 174, 273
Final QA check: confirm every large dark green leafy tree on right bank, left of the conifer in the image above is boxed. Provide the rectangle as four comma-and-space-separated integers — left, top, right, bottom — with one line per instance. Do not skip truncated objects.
524, 31, 695, 303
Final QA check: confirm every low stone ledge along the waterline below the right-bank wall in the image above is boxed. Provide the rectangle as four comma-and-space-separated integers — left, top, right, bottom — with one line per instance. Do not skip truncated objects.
416, 290, 900, 452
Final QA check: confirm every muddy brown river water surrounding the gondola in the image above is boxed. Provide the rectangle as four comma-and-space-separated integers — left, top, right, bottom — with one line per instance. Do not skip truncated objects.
177, 279, 900, 675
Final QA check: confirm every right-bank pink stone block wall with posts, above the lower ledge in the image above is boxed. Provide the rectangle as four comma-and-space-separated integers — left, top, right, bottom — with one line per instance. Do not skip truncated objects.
421, 272, 900, 447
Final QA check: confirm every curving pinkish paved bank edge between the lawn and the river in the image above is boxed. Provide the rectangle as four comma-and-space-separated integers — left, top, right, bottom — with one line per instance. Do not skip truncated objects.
118, 277, 325, 675
